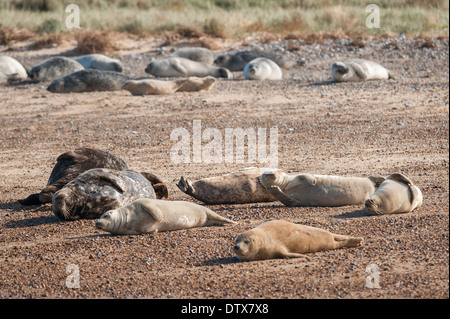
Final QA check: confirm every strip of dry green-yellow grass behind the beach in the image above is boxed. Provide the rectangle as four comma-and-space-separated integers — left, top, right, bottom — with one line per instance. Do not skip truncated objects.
0, 0, 449, 38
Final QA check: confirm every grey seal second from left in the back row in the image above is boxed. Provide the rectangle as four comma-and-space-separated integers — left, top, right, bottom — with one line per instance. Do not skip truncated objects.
29, 56, 84, 82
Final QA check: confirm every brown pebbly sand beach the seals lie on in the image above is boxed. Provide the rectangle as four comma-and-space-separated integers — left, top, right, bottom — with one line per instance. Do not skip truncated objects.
0, 35, 449, 299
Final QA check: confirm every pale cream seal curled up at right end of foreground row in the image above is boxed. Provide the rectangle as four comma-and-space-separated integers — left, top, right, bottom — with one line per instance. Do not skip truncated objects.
365, 173, 423, 215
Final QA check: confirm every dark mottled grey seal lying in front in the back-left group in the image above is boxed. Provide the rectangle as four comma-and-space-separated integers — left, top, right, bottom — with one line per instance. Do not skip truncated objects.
47, 69, 131, 93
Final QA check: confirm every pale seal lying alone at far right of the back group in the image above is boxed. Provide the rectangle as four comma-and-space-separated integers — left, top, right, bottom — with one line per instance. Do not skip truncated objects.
331, 59, 393, 82
